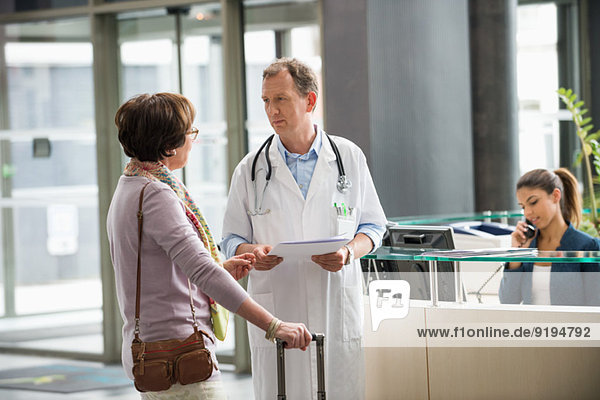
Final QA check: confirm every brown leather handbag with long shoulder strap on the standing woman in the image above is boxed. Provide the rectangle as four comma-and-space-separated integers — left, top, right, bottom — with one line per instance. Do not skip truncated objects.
131, 182, 216, 392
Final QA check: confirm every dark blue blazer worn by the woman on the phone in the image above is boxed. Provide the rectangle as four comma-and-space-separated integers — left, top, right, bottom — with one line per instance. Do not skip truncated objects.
499, 223, 600, 306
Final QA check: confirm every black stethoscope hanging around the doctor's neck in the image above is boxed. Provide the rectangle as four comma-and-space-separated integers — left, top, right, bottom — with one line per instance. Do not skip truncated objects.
247, 132, 352, 216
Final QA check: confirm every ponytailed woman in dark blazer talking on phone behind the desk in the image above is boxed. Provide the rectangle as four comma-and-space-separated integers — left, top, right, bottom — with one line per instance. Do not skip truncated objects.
499, 168, 600, 306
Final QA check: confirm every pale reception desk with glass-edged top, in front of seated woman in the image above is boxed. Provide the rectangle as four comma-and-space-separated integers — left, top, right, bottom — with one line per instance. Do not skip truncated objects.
364, 247, 600, 400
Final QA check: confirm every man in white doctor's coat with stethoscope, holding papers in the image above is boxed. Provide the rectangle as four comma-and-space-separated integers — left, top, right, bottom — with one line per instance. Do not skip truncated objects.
221, 58, 386, 400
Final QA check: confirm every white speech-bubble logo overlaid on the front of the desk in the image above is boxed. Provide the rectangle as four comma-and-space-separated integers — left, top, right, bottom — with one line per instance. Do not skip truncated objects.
369, 280, 410, 331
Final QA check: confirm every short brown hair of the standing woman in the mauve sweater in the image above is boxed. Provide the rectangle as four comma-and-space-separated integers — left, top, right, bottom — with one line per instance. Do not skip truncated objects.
115, 93, 196, 161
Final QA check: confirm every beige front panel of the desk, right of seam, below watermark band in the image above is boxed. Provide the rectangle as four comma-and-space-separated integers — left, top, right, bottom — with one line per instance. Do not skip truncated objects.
429, 347, 600, 400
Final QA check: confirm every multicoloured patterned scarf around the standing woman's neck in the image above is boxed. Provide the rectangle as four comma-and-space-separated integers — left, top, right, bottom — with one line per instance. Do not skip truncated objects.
123, 158, 229, 340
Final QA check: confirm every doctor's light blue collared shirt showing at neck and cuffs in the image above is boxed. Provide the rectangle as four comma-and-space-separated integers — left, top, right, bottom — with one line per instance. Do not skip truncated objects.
221, 125, 385, 258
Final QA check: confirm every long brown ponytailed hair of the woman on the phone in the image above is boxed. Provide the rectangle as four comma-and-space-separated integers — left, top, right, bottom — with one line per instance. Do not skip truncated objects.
517, 168, 582, 227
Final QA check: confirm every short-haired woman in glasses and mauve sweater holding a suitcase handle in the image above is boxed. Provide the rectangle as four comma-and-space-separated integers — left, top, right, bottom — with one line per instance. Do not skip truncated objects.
107, 93, 311, 399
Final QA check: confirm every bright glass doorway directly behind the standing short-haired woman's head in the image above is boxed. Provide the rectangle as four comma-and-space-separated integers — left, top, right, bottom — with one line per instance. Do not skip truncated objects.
117, 3, 234, 356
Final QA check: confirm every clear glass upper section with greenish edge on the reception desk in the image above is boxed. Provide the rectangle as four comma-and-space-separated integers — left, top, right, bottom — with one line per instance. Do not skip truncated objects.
361, 246, 600, 307
